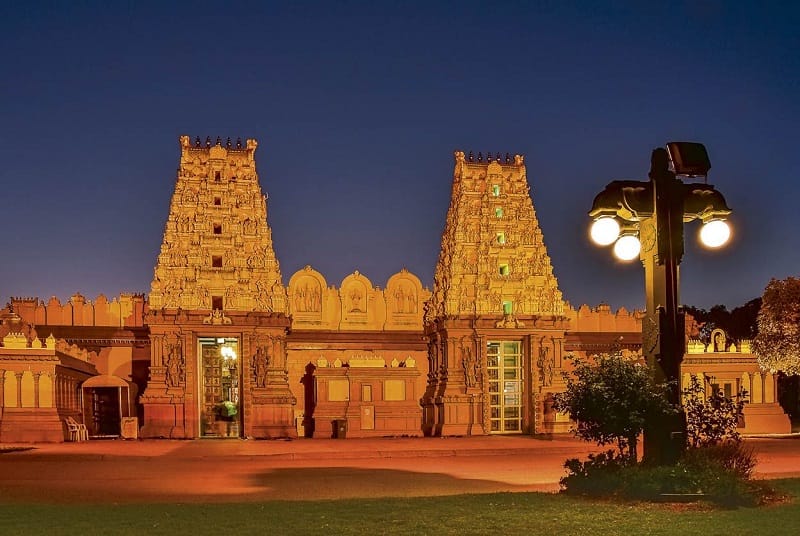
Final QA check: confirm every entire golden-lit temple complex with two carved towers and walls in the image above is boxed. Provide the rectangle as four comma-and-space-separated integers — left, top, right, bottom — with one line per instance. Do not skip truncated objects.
0, 136, 791, 442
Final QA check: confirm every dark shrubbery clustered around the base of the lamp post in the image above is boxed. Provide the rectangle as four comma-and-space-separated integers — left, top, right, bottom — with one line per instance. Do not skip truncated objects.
555, 354, 776, 507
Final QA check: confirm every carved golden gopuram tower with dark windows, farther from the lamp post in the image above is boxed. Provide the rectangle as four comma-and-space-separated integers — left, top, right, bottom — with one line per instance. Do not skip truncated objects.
141, 136, 297, 438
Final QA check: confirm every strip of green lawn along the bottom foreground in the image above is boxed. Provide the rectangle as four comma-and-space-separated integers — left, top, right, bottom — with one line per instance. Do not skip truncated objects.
0, 479, 800, 536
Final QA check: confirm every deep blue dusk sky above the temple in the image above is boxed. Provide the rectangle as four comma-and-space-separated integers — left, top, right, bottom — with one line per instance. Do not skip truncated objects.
0, 0, 800, 309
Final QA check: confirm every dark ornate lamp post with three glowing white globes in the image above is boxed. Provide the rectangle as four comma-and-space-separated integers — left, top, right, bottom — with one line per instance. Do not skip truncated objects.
589, 142, 731, 465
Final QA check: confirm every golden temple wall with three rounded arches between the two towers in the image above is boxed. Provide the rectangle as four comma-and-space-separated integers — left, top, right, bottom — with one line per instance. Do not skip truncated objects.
287, 266, 430, 437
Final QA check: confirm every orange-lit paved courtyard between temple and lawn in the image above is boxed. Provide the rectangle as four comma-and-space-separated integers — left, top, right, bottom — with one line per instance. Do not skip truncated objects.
0, 436, 800, 504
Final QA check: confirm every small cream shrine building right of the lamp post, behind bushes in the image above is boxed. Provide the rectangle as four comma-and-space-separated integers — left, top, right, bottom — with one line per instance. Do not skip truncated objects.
681, 329, 792, 434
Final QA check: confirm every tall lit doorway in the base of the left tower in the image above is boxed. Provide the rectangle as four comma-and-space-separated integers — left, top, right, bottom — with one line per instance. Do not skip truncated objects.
197, 337, 242, 437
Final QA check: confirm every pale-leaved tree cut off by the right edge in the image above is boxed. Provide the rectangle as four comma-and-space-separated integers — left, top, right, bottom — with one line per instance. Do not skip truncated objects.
753, 277, 800, 375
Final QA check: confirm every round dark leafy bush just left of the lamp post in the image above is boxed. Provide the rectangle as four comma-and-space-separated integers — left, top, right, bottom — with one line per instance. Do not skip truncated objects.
553, 352, 678, 463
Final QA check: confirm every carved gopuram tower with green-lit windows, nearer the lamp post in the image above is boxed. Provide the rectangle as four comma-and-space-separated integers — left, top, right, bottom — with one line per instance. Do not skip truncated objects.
421, 151, 568, 435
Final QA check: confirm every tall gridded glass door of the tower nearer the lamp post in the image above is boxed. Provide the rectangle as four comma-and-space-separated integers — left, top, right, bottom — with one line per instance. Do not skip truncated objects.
486, 341, 525, 434
